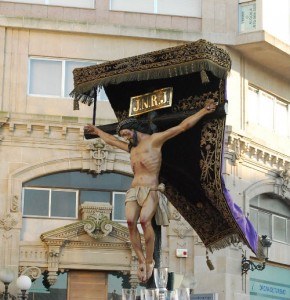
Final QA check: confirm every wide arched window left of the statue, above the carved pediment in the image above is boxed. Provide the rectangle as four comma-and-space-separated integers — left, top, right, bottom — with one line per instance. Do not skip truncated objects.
22, 171, 132, 221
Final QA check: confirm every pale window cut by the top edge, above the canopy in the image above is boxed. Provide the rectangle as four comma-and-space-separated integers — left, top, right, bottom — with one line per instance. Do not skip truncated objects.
110, 0, 201, 18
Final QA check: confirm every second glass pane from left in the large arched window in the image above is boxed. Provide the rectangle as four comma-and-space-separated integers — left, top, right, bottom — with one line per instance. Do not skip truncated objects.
51, 191, 77, 218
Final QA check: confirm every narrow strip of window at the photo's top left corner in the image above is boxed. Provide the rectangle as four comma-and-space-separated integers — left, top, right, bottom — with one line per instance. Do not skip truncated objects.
2, 0, 95, 8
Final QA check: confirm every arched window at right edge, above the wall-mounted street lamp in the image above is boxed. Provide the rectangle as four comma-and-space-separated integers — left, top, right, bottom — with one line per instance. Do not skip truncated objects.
250, 193, 290, 244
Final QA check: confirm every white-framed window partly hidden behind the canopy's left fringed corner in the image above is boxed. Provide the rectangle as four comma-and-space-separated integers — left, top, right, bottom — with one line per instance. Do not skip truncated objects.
28, 58, 108, 100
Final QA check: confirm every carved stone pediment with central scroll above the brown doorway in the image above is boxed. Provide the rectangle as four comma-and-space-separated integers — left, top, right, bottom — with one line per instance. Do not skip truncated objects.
37, 209, 138, 286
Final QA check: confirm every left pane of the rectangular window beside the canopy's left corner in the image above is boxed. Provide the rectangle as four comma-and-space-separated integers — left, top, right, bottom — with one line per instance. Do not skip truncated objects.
29, 59, 62, 96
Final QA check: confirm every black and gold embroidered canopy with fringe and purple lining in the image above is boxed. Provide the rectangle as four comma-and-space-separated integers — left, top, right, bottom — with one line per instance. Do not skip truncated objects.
71, 40, 259, 254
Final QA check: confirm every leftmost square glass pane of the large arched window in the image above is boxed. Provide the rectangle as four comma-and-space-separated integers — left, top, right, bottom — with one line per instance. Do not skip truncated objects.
23, 189, 49, 216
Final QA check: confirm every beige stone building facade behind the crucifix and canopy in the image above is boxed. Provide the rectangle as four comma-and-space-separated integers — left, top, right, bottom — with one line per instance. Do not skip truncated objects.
0, 0, 290, 300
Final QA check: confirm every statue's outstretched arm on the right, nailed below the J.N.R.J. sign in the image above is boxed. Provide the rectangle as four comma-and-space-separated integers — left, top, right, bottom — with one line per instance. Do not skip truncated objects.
155, 99, 217, 146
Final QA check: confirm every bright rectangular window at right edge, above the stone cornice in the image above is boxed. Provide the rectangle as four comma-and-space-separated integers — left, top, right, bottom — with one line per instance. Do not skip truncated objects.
248, 86, 290, 136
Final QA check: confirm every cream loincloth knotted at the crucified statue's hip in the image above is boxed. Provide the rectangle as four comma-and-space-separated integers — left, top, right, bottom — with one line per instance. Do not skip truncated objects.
125, 183, 170, 226
